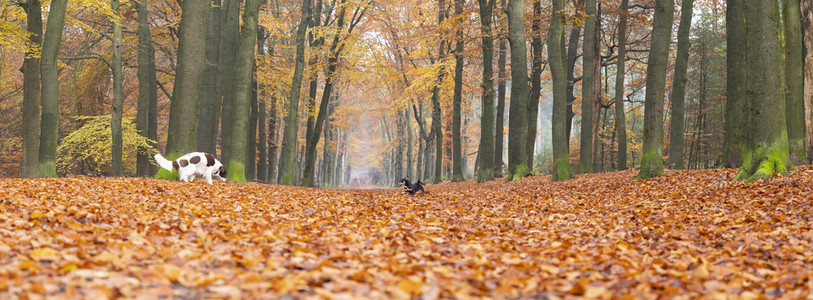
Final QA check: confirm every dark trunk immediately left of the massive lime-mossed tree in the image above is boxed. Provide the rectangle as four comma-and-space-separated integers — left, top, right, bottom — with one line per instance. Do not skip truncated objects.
722, 0, 750, 168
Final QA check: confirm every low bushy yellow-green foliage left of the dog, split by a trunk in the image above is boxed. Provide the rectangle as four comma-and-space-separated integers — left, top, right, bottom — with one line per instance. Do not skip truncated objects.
57, 115, 157, 176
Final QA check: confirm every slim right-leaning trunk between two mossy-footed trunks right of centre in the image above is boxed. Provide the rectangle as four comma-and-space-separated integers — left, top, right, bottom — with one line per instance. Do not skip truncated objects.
525, 1, 543, 174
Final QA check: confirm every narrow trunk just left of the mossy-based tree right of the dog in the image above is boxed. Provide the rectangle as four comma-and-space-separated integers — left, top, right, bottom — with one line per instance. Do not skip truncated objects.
217, 0, 240, 166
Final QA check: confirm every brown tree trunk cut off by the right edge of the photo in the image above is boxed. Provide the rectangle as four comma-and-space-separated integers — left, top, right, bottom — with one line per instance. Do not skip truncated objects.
801, 0, 813, 163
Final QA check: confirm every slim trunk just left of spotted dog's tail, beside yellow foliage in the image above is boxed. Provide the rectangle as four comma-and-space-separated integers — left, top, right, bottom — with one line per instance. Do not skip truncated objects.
135, 1, 158, 177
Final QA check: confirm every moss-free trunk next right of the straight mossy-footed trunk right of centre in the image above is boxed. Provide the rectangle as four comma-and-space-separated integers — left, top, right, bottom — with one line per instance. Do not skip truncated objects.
579, 0, 601, 174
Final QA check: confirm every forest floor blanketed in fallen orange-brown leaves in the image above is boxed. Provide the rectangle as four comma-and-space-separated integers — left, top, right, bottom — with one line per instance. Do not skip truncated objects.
0, 167, 813, 299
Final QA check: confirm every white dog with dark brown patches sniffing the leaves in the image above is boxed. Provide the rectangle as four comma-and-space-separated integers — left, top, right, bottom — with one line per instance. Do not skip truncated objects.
155, 152, 226, 184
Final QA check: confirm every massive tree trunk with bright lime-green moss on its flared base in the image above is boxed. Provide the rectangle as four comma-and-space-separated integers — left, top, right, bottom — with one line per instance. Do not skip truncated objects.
728, 0, 792, 181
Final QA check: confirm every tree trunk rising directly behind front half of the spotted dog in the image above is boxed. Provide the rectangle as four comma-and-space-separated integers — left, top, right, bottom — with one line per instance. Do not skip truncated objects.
198, 0, 222, 153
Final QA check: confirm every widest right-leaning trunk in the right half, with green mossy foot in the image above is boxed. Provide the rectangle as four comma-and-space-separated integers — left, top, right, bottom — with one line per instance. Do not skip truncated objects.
635, 0, 675, 180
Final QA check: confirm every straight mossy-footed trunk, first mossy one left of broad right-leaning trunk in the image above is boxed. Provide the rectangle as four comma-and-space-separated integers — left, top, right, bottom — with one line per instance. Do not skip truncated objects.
548, 0, 573, 181
